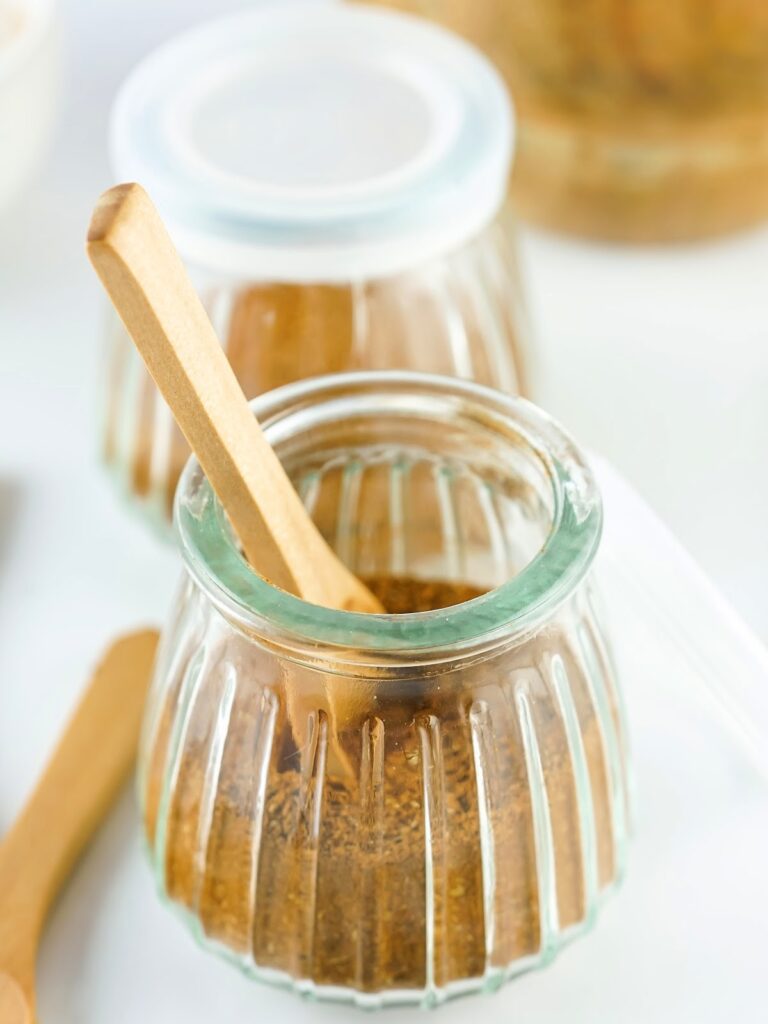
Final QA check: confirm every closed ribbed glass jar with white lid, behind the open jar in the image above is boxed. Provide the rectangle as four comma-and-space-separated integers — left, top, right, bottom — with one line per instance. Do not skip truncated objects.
104, 5, 527, 521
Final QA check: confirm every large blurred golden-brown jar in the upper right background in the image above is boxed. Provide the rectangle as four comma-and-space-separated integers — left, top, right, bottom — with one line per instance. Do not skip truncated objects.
378, 0, 768, 241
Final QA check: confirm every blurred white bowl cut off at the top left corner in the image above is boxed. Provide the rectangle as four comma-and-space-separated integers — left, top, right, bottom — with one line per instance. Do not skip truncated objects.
0, 0, 58, 209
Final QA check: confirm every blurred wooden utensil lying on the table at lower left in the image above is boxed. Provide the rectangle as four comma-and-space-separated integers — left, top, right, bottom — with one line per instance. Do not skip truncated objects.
0, 630, 158, 1024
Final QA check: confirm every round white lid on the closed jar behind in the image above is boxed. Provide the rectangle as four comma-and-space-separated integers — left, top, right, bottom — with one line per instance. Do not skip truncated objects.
111, 2, 512, 282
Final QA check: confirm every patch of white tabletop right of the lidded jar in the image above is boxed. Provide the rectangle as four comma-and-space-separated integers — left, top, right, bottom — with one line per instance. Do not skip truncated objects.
523, 225, 768, 641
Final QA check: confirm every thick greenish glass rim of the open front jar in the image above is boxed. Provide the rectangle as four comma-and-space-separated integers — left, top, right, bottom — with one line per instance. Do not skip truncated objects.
174, 372, 602, 662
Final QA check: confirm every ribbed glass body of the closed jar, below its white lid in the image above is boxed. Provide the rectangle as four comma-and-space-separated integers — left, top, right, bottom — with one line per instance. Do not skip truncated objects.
103, 207, 529, 524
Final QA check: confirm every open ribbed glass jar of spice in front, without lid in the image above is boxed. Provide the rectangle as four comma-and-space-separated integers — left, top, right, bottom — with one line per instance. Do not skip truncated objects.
139, 373, 628, 1007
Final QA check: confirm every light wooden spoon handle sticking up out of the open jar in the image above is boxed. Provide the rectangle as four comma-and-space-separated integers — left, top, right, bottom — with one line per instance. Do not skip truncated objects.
88, 184, 382, 611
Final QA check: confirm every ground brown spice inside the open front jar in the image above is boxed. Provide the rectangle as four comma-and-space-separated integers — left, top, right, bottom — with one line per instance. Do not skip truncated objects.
144, 578, 615, 992
